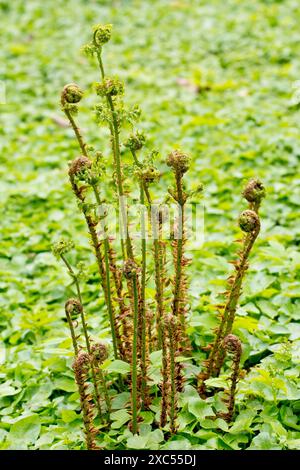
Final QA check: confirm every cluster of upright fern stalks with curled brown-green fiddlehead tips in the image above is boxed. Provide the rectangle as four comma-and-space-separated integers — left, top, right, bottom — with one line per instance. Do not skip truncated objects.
53, 25, 264, 449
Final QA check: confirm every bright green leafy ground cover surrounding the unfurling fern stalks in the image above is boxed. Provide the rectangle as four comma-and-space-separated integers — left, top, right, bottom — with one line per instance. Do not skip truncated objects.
0, 0, 300, 450
